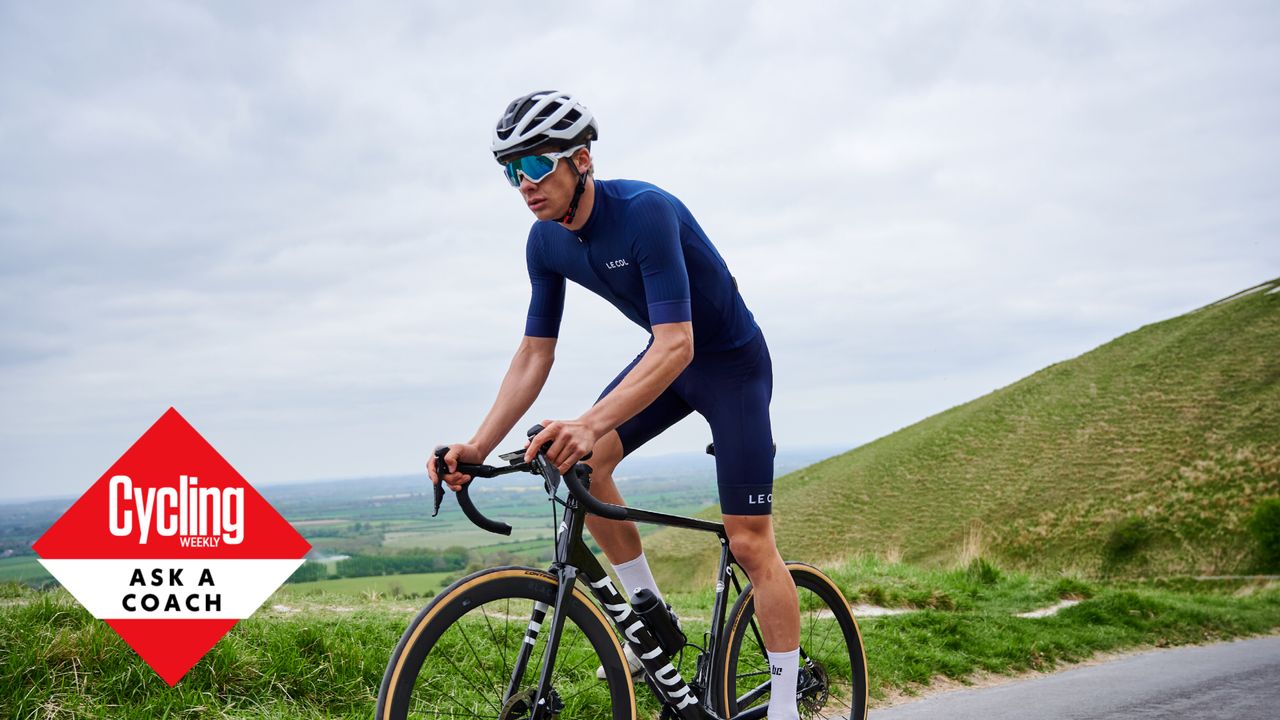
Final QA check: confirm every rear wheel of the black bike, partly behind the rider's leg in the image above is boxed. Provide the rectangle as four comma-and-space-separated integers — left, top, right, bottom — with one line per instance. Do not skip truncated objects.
714, 562, 868, 720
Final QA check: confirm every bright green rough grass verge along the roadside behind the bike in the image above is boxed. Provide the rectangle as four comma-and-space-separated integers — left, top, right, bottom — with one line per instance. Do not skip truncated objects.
0, 557, 1280, 719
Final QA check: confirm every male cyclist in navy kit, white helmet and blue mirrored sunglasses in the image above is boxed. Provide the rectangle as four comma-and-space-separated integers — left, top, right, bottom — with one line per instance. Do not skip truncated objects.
426, 91, 800, 720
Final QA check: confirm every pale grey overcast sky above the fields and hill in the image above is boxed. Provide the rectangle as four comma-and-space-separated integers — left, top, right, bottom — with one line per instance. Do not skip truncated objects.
0, 1, 1280, 501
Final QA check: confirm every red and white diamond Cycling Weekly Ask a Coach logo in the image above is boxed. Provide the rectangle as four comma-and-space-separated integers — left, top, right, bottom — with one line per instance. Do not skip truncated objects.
33, 407, 311, 685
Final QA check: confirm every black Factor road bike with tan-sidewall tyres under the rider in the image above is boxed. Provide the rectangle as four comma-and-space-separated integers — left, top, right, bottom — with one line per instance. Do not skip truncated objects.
375, 425, 868, 720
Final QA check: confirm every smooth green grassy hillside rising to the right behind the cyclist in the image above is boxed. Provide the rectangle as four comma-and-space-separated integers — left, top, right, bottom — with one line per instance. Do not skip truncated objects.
646, 279, 1280, 584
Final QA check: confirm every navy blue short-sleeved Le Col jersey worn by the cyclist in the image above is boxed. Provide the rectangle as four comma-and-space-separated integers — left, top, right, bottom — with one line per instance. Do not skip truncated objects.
525, 179, 759, 352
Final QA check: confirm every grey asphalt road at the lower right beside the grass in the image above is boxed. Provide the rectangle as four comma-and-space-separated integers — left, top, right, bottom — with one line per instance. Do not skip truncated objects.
870, 637, 1280, 720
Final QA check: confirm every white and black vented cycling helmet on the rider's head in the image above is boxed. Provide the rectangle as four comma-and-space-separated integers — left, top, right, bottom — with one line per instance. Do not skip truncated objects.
489, 90, 600, 163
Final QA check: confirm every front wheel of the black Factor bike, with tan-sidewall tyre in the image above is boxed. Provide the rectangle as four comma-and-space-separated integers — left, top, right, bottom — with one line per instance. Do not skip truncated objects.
374, 566, 636, 720
